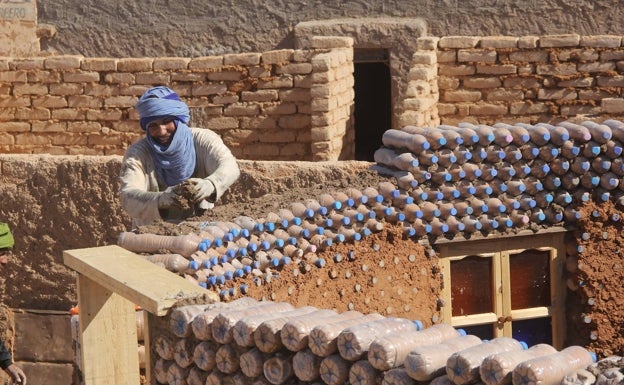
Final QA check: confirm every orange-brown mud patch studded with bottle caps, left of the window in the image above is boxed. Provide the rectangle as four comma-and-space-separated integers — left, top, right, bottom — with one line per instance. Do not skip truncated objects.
217, 225, 441, 326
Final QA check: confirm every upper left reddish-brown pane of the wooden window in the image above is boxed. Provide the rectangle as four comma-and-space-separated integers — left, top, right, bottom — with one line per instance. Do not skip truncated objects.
451, 256, 494, 316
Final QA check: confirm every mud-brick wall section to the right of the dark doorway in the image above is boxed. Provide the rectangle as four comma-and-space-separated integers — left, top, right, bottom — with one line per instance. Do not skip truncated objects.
404, 34, 624, 124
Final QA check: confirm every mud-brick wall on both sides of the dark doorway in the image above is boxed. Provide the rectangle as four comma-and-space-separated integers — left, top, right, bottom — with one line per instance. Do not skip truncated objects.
6, 34, 624, 161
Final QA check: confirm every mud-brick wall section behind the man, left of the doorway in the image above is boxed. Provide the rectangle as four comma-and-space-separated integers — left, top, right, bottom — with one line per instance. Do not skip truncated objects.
0, 38, 354, 160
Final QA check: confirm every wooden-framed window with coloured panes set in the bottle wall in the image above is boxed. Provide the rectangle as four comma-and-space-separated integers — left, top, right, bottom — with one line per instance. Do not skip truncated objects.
436, 229, 566, 349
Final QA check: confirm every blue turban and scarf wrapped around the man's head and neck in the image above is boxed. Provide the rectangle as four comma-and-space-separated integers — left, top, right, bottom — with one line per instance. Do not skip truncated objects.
135, 86, 195, 186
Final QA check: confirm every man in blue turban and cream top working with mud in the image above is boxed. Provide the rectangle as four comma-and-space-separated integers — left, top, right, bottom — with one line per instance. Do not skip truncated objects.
120, 86, 240, 226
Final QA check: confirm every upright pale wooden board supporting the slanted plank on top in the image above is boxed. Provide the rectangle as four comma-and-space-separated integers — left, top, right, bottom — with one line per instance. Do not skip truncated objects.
78, 275, 140, 385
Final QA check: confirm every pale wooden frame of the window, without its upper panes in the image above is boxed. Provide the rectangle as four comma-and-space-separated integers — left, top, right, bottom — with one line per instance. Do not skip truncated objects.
434, 228, 567, 349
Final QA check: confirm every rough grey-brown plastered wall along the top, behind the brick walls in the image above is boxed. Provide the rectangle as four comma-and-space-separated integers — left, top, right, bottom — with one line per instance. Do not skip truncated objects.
37, 0, 624, 57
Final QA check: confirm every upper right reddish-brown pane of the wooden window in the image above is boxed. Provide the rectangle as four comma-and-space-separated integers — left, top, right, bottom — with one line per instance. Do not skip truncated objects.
509, 250, 550, 310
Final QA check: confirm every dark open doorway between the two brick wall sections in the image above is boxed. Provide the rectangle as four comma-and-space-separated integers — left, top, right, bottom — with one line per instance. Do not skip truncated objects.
353, 49, 392, 161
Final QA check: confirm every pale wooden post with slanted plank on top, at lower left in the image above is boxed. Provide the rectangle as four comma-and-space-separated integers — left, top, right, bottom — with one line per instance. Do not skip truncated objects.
63, 245, 219, 385
